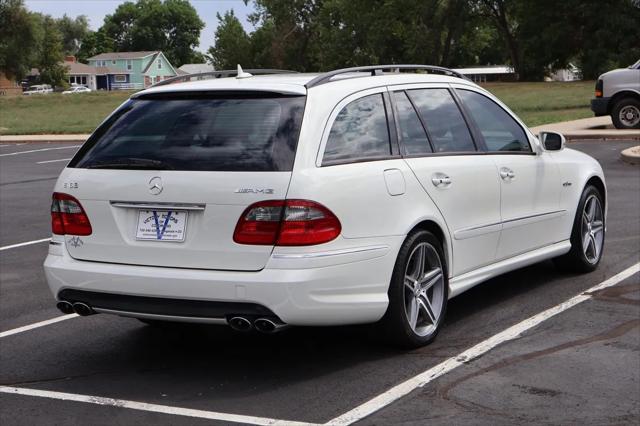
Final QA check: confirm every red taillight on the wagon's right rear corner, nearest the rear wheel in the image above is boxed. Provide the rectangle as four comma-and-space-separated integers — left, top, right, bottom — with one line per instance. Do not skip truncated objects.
233, 200, 342, 246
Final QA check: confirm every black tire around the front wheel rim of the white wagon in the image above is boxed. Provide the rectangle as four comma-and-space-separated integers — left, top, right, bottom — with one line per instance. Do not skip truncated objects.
553, 185, 606, 273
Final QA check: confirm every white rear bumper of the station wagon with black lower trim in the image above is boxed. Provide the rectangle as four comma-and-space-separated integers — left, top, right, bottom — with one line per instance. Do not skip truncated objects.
44, 237, 402, 325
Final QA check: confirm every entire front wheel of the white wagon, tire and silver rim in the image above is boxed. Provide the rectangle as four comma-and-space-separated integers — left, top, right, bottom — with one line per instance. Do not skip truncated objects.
554, 185, 605, 272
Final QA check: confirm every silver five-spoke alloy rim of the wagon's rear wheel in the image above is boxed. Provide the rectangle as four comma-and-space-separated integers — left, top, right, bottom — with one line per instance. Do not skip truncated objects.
403, 242, 445, 336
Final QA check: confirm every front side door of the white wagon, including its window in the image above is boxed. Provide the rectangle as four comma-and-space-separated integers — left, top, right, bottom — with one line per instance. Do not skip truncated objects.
456, 89, 566, 260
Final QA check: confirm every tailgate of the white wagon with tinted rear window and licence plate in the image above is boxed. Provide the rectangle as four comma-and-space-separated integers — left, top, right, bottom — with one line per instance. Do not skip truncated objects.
56, 92, 305, 271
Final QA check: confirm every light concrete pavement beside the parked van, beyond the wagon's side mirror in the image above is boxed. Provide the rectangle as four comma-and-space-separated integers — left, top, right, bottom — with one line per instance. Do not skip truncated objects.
530, 116, 640, 140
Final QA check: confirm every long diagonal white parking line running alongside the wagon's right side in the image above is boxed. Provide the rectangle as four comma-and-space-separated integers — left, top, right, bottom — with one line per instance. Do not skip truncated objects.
326, 262, 640, 426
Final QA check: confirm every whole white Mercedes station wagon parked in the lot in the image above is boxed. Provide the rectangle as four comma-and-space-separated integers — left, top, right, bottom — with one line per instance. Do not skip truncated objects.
44, 65, 606, 347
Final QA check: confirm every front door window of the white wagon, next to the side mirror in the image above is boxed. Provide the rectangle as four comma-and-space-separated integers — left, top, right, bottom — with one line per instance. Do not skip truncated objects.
458, 90, 531, 152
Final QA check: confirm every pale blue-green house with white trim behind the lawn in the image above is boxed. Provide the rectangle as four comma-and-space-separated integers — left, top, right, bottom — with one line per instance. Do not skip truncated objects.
88, 51, 178, 90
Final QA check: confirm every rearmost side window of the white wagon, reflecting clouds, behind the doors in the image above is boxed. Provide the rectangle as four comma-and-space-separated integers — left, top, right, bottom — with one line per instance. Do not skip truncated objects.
322, 94, 391, 165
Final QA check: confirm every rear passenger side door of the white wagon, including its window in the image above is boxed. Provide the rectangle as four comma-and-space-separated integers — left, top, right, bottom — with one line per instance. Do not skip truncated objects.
393, 86, 500, 276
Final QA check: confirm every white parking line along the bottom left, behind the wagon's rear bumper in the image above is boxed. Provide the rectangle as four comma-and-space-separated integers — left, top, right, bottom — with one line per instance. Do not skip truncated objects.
0, 386, 315, 426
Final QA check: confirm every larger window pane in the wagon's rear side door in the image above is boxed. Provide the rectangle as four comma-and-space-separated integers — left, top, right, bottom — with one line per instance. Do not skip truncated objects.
407, 89, 476, 152
